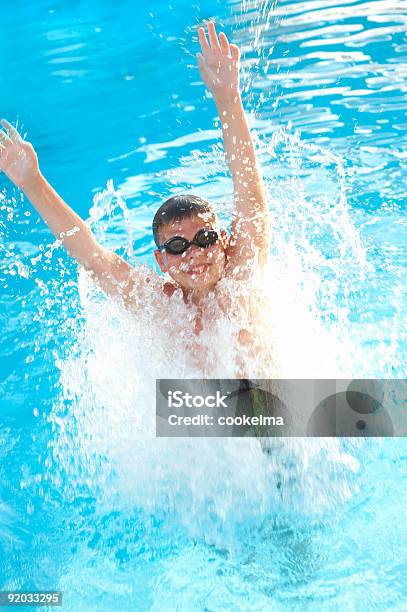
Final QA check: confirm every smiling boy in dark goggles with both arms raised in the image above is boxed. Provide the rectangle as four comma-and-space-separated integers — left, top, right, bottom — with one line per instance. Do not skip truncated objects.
0, 22, 269, 335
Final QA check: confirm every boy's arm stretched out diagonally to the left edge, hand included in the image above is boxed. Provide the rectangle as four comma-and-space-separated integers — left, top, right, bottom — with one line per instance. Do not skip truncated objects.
0, 119, 139, 303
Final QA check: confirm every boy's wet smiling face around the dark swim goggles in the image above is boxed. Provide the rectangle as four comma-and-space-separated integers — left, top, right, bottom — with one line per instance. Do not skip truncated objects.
154, 215, 228, 290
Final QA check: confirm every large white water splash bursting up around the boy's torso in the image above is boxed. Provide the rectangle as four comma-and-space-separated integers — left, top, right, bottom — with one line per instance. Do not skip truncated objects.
39, 124, 384, 549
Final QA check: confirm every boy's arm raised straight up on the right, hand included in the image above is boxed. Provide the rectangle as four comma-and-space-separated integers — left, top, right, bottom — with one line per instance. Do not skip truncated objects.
197, 22, 270, 266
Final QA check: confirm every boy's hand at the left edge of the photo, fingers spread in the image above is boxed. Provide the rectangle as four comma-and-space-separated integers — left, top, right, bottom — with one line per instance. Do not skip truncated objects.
0, 119, 39, 189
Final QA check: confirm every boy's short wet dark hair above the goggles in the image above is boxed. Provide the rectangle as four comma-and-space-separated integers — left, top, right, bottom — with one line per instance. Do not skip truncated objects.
153, 194, 216, 246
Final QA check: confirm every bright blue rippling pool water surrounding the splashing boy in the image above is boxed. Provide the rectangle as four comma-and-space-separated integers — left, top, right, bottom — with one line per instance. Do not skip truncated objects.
0, 0, 407, 611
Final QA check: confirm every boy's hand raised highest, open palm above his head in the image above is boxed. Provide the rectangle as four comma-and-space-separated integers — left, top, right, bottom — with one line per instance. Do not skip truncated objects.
197, 21, 240, 102
